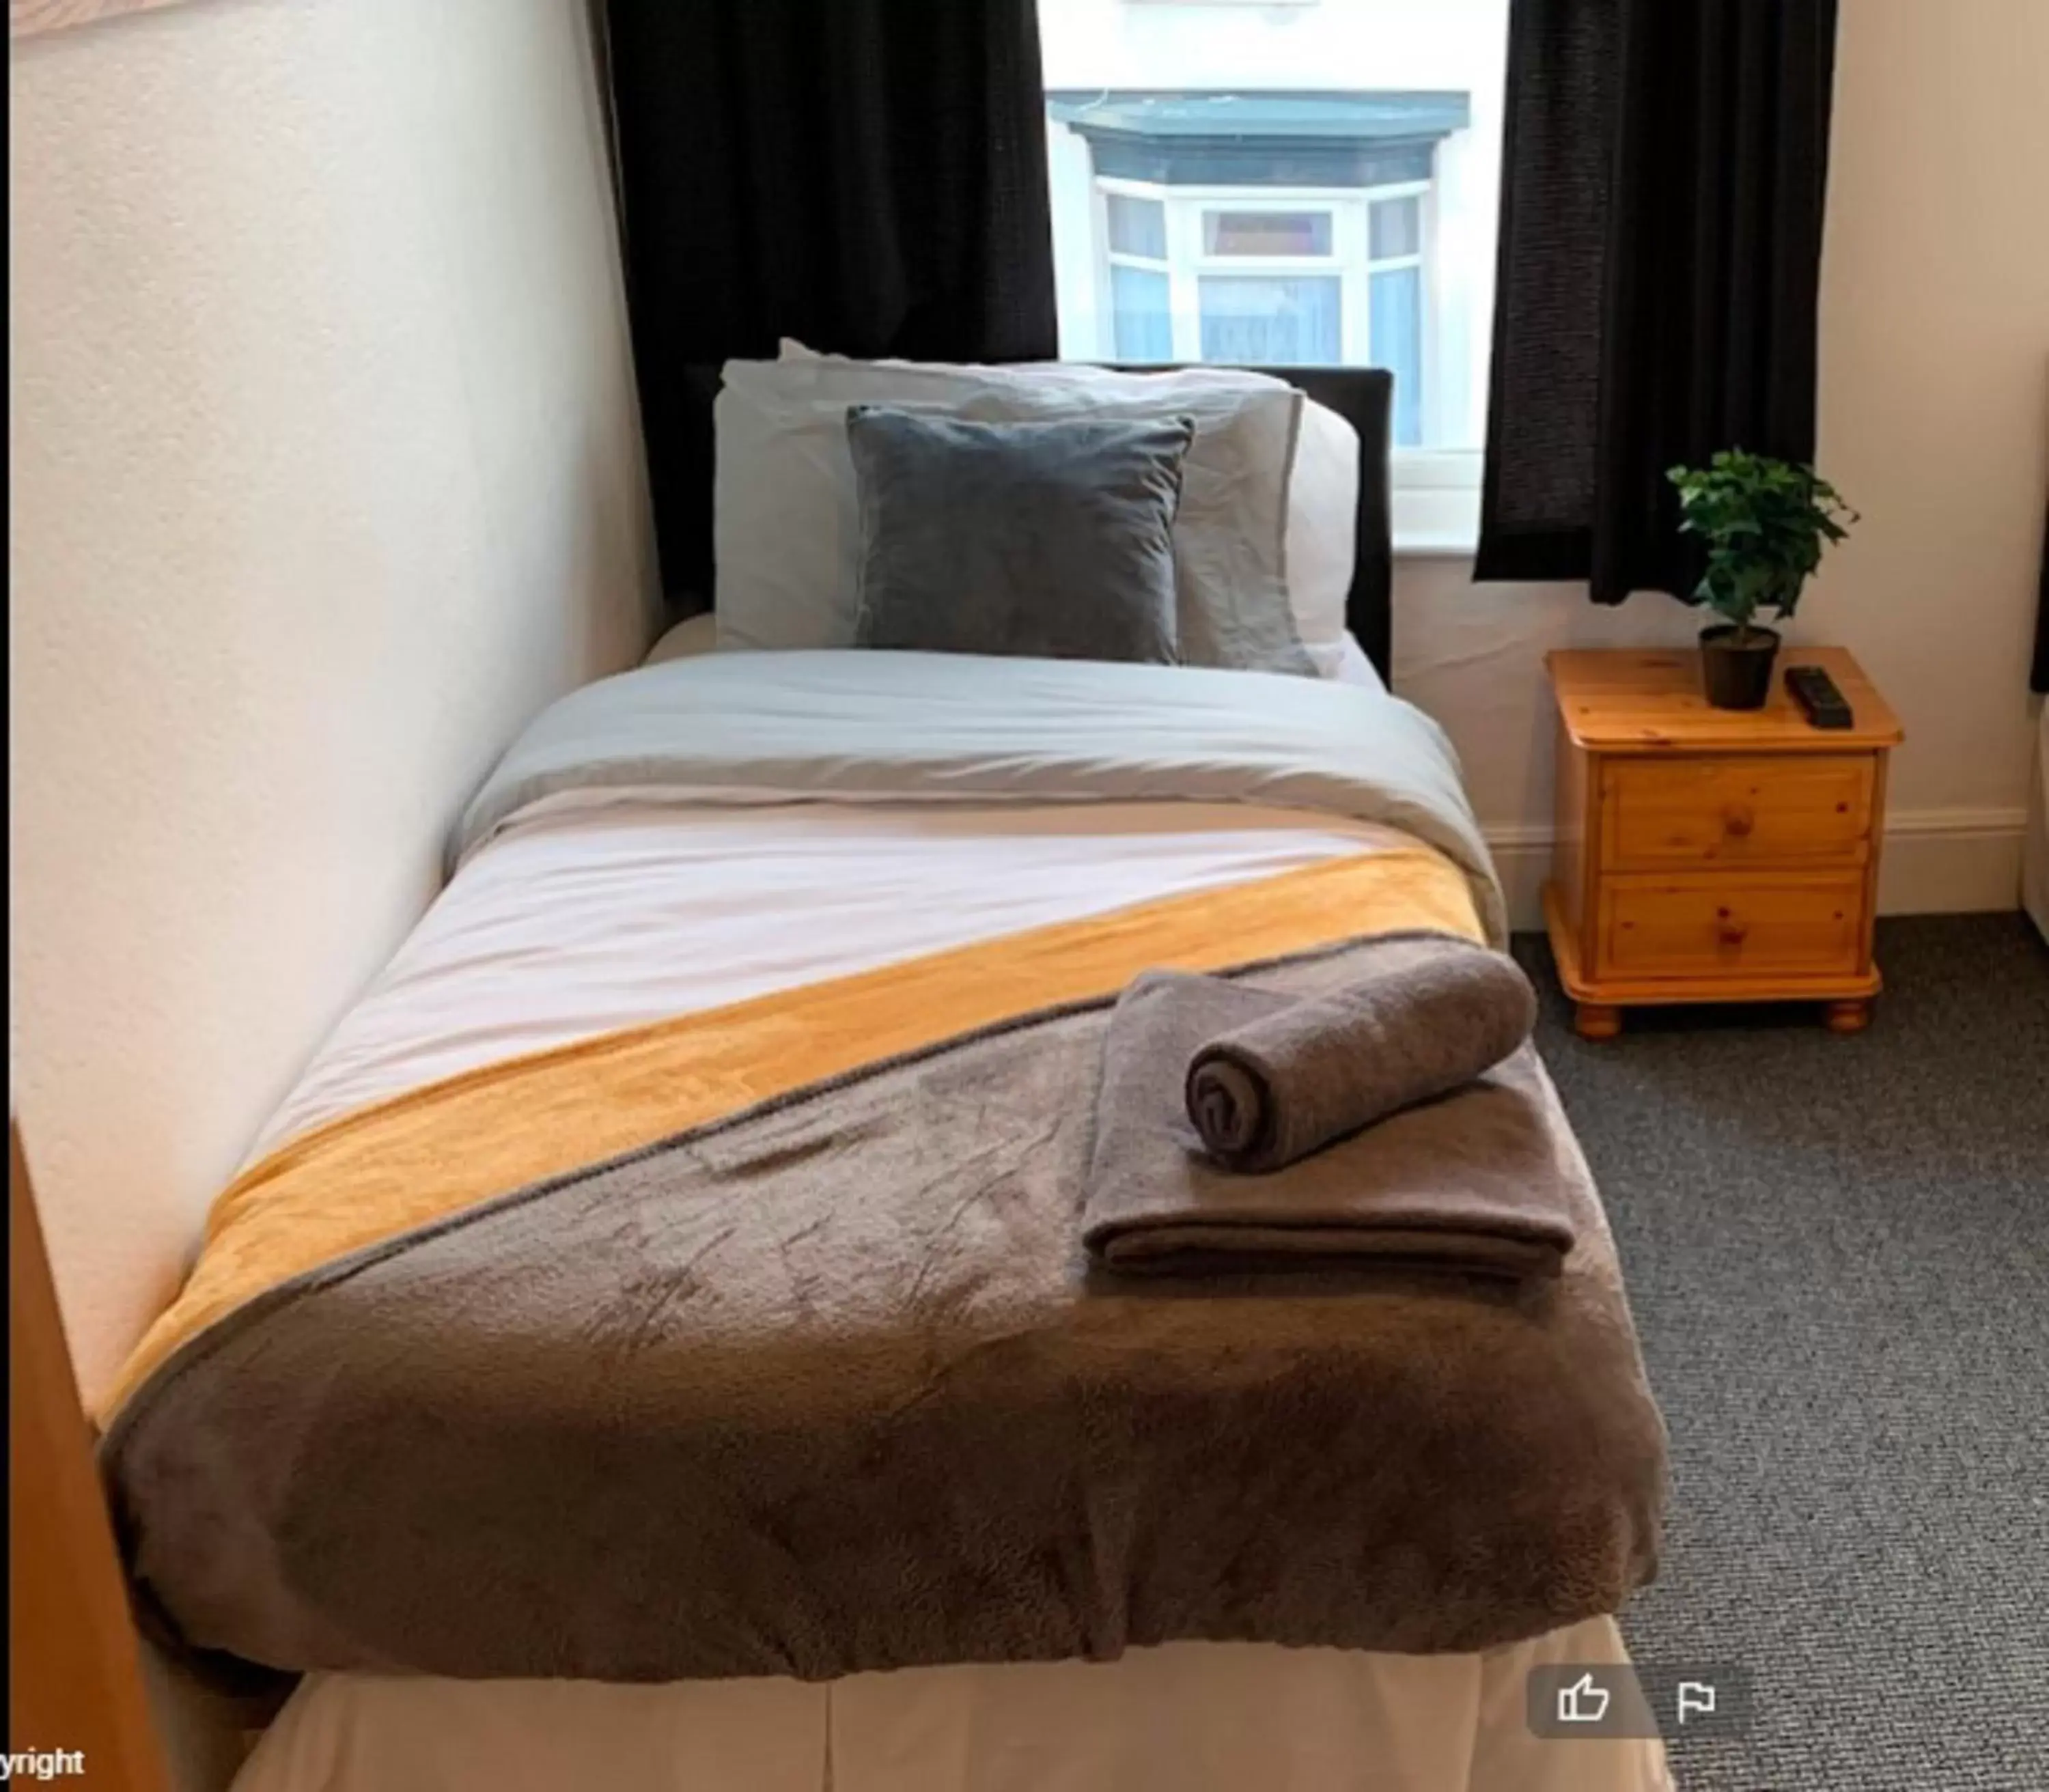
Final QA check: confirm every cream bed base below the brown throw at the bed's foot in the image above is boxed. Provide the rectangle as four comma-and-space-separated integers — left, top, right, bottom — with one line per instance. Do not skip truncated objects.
236, 1620, 1674, 1792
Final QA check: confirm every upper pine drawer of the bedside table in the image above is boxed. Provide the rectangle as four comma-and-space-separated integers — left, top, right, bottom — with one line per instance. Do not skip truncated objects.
1600, 754, 1877, 871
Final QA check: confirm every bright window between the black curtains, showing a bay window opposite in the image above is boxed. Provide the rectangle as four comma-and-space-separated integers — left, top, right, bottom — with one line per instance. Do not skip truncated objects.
1037, 0, 1510, 451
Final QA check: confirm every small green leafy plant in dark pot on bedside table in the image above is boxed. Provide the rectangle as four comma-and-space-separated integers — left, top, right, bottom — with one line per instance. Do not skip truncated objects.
1666, 449, 1856, 709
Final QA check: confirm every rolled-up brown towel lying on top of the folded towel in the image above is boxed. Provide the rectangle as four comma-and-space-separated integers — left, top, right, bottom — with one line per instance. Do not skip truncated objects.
1186, 934, 1537, 1169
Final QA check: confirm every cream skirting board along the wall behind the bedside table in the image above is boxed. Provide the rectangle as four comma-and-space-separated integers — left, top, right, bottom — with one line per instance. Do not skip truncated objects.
1481, 809, 2029, 932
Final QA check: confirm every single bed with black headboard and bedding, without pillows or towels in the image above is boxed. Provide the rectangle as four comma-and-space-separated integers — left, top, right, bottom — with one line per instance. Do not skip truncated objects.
102, 358, 1668, 1792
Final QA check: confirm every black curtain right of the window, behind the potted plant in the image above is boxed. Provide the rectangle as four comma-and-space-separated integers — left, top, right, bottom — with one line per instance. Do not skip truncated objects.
1475, 0, 1836, 602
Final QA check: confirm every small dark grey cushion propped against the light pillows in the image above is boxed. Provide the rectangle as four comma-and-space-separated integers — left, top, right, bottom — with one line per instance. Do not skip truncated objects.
846, 406, 1195, 666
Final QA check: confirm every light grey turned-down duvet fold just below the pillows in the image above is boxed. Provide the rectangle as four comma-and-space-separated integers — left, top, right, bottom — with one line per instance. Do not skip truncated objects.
455, 649, 1506, 925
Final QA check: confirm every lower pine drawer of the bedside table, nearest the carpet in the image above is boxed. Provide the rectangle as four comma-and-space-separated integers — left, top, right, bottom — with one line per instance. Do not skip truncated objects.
1596, 871, 1865, 979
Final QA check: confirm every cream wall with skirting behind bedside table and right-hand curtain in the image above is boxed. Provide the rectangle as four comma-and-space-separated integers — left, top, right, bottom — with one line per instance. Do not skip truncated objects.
1395, 0, 2049, 921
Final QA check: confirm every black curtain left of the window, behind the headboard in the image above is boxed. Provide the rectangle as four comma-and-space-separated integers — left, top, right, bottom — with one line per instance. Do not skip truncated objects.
604, 0, 1057, 596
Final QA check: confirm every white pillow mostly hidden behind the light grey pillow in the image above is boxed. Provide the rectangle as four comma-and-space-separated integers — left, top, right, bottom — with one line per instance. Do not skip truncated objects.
777, 336, 1358, 678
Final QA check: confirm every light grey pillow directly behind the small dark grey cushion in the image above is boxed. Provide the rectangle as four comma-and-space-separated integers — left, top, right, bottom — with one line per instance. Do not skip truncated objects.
713, 359, 1318, 674
